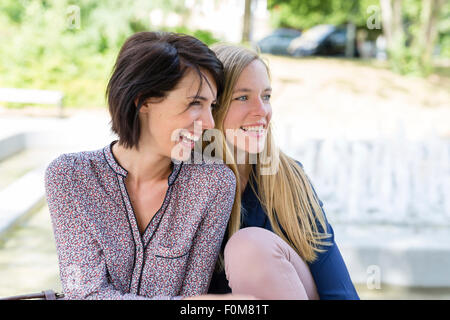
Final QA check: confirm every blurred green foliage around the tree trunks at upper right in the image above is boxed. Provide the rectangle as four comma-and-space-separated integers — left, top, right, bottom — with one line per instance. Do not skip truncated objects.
268, 0, 450, 76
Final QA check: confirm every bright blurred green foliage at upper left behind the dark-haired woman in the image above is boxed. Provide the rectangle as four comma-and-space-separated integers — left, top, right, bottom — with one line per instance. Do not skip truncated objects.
0, 0, 223, 107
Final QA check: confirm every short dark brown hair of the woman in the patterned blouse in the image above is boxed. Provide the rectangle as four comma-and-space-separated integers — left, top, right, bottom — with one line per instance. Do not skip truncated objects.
106, 32, 224, 148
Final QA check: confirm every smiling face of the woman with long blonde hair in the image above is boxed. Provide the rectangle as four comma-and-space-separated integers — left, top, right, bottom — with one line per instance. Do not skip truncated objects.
223, 60, 272, 154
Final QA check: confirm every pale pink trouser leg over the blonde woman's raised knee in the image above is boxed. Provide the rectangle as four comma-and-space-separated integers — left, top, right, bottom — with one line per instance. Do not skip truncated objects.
224, 227, 319, 300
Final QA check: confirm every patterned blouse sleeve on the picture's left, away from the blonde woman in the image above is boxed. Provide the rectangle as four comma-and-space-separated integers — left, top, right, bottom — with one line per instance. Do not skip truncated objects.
45, 155, 181, 300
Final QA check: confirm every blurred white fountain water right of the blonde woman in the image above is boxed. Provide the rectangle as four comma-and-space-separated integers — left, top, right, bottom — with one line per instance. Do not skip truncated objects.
284, 131, 450, 226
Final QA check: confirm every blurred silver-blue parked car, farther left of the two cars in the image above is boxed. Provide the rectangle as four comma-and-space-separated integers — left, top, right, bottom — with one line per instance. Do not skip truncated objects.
257, 28, 302, 55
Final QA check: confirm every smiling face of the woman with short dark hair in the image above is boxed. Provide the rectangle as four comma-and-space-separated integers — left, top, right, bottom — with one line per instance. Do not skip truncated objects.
140, 70, 217, 160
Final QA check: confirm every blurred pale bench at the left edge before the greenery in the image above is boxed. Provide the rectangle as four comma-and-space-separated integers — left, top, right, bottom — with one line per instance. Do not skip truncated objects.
0, 88, 64, 117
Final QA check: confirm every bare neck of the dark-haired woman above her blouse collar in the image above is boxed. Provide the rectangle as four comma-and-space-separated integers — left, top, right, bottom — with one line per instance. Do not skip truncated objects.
113, 143, 171, 185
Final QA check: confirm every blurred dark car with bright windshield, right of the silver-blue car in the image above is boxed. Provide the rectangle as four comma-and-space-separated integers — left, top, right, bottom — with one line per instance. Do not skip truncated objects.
287, 24, 358, 57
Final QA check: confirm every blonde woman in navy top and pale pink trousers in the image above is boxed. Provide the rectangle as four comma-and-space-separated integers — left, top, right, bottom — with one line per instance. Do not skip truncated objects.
209, 44, 359, 299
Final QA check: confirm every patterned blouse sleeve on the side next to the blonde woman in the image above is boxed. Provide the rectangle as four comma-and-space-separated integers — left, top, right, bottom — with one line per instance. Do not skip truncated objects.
181, 165, 236, 296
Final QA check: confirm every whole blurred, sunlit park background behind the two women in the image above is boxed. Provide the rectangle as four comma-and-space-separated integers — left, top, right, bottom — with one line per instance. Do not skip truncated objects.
0, 0, 450, 299
